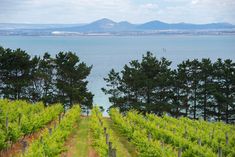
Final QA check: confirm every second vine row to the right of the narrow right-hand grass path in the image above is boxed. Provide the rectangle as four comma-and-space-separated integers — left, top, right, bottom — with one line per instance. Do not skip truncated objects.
125, 112, 216, 157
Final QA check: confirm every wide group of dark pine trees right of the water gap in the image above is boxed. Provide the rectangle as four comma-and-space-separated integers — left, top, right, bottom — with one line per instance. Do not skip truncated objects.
102, 52, 235, 123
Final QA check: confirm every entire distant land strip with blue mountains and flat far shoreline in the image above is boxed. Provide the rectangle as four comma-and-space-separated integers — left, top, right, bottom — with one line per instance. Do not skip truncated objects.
0, 18, 235, 35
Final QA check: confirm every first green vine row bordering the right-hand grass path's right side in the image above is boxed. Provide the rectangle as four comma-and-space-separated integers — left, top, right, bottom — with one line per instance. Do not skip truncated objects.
110, 109, 177, 157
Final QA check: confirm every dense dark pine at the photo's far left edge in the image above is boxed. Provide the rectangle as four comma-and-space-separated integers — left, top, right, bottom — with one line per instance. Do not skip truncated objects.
0, 49, 38, 99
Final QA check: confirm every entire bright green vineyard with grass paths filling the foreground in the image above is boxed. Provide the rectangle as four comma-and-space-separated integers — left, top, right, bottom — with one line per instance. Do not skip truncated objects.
0, 99, 235, 157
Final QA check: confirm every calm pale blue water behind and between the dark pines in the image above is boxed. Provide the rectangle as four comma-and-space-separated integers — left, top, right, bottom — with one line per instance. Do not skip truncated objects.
0, 35, 235, 114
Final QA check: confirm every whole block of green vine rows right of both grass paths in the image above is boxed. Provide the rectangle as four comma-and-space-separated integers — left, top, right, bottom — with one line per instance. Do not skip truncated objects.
110, 109, 235, 157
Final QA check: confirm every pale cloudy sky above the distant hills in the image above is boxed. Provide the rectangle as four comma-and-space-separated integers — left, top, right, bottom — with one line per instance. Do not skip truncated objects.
0, 0, 235, 24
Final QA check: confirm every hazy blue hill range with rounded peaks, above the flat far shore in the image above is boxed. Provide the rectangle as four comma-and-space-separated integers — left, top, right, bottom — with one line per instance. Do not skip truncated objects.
57, 19, 235, 32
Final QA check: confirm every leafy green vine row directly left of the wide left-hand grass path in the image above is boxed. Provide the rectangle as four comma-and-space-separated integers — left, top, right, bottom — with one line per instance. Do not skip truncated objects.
23, 105, 81, 157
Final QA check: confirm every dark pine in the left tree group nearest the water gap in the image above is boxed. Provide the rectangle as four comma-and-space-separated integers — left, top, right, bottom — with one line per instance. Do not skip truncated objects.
55, 52, 93, 108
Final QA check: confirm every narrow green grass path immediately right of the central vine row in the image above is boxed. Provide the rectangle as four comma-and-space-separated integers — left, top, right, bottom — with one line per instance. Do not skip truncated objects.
106, 118, 138, 157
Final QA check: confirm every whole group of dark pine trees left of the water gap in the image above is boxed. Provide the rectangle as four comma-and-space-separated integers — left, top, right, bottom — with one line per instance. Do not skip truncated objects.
0, 47, 93, 108
